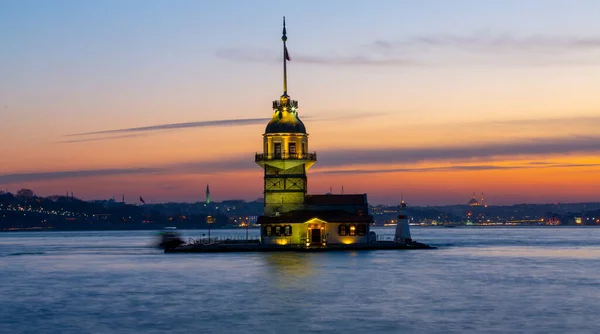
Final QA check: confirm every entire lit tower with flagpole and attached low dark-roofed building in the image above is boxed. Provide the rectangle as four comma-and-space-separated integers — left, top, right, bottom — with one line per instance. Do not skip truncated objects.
255, 19, 373, 247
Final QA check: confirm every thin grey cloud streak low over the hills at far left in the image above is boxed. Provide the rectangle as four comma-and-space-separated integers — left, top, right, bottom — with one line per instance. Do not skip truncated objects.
0, 168, 165, 184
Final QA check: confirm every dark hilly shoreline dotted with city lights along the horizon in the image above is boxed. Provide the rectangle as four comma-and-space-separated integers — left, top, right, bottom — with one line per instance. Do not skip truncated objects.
0, 189, 600, 231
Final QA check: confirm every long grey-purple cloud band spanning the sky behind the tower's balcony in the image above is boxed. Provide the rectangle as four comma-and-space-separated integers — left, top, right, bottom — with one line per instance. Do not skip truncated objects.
7, 137, 600, 184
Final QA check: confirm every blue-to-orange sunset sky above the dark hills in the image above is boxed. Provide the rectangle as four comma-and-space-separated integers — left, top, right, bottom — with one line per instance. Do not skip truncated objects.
0, 0, 600, 205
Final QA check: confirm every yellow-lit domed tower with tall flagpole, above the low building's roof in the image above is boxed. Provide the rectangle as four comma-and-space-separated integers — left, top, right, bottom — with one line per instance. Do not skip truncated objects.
255, 17, 317, 216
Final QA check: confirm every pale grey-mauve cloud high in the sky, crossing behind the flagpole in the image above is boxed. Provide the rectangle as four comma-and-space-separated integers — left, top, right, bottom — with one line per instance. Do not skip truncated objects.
216, 33, 600, 67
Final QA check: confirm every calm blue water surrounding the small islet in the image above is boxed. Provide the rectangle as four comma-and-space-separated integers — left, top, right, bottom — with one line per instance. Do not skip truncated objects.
0, 228, 600, 333
